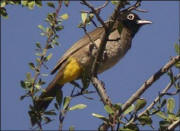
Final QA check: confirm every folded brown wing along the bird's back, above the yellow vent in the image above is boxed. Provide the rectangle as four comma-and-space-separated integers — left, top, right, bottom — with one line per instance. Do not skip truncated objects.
51, 27, 104, 74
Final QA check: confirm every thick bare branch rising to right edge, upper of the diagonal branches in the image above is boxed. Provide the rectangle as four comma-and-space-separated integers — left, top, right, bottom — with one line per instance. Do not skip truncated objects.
120, 55, 180, 115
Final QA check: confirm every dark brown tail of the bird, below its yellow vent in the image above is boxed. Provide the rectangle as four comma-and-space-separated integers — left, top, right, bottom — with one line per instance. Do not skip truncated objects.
36, 80, 63, 111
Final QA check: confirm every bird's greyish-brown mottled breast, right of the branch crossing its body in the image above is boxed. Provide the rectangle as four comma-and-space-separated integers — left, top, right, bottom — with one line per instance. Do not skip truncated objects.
98, 30, 132, 73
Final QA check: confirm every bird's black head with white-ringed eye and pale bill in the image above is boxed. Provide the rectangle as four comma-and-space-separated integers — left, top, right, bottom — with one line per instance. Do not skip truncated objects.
121, 12, 152, 37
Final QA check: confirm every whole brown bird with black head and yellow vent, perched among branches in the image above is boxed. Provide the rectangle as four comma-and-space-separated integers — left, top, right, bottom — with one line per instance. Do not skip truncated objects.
37, 12, 152, 110
